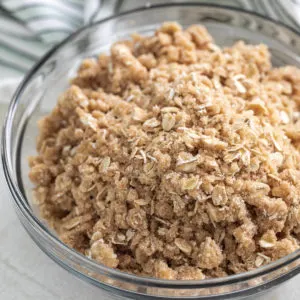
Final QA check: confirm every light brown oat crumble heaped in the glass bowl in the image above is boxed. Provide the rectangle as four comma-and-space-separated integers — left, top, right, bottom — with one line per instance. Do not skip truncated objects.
29, 23, 300, 280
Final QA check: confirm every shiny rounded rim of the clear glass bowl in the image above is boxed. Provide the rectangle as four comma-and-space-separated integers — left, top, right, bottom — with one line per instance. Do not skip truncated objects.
1, 2, 300, 289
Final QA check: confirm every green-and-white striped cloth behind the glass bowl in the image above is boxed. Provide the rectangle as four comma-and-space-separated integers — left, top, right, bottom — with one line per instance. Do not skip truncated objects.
0, 0, 300, 81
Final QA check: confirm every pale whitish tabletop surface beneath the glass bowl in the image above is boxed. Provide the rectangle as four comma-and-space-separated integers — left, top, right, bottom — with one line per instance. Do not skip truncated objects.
0, 99, 300, 300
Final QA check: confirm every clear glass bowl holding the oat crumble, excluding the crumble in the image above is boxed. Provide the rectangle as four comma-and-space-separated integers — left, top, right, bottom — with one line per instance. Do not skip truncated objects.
2, 3, 300, 299
